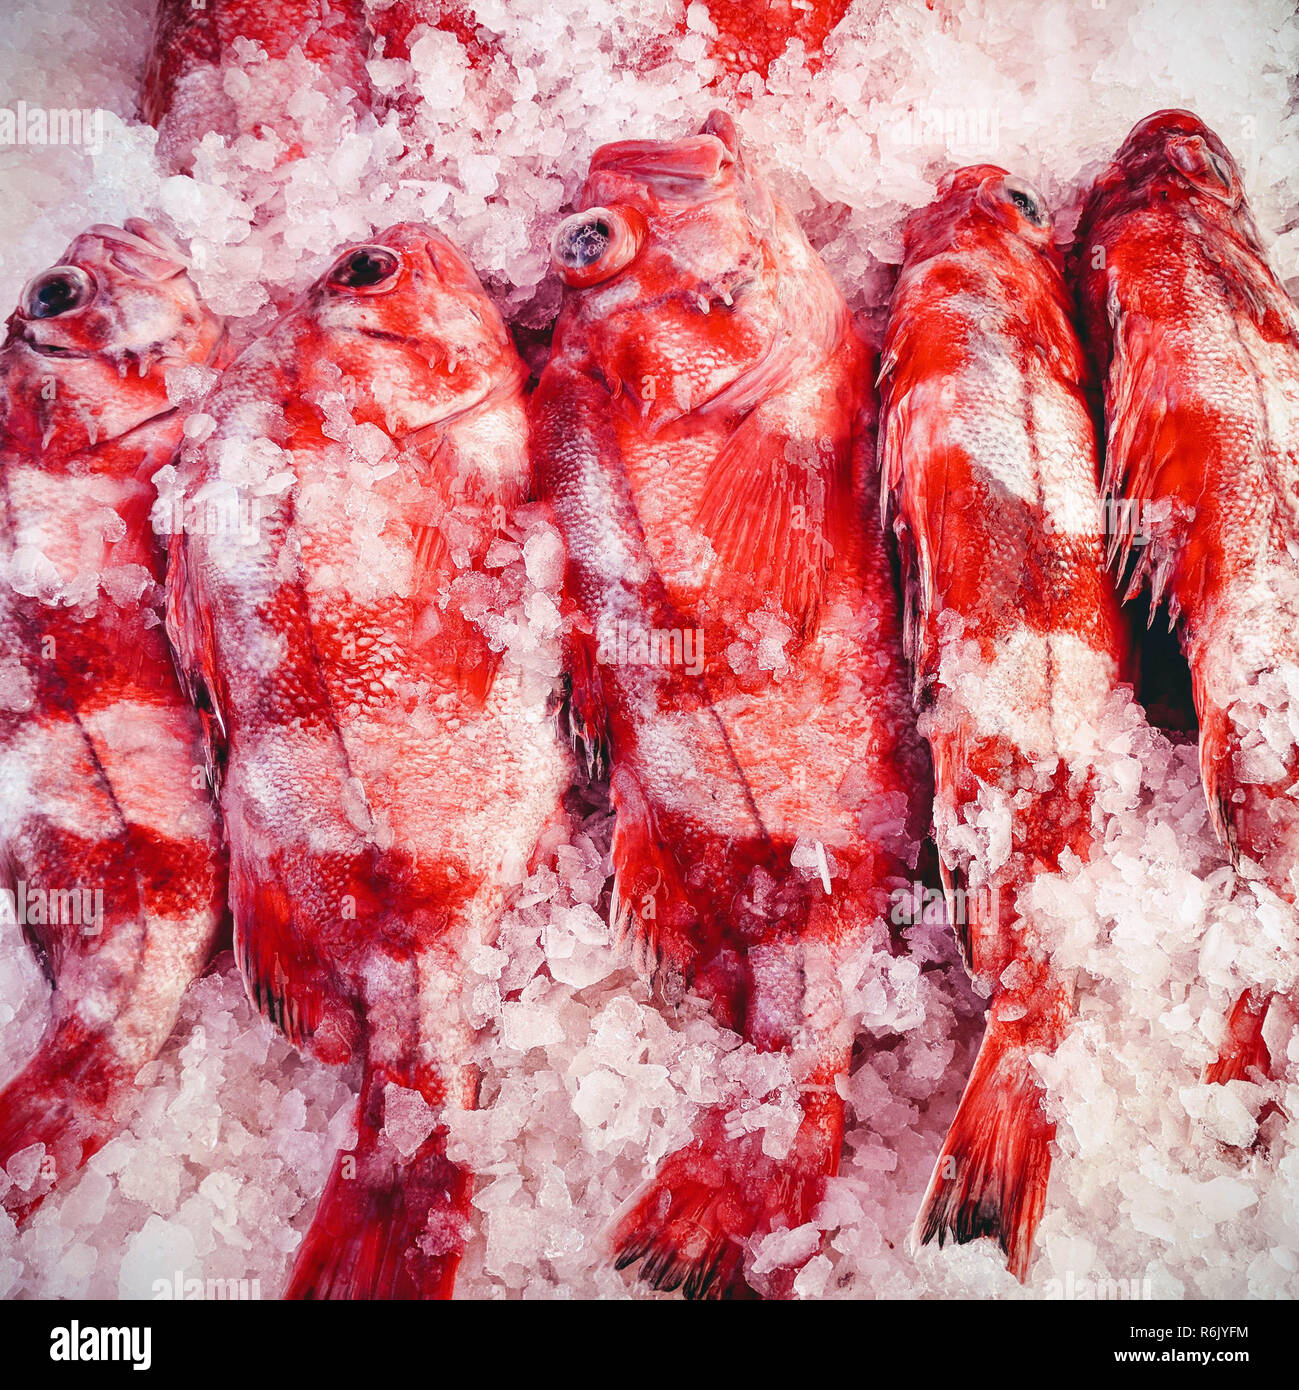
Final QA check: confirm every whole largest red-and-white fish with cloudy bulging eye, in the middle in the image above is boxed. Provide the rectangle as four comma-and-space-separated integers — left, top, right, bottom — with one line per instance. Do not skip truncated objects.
532, 113, 928, 1297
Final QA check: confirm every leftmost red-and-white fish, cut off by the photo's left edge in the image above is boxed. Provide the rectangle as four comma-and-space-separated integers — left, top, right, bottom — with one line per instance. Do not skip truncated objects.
0, 220, 225, 1219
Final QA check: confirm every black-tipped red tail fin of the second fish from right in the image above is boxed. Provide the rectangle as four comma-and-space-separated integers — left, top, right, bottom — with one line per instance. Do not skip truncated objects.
911, 1019, 1056, 1283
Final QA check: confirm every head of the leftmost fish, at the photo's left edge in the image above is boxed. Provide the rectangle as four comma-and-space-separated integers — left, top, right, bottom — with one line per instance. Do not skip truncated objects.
0, 217, 221, 456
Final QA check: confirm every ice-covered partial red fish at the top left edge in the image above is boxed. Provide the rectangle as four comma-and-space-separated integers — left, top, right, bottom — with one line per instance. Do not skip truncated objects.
140, 0, 371, 174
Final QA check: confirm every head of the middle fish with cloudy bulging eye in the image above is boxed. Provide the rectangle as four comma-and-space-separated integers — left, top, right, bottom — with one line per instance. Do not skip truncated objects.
552, 111, 811, 428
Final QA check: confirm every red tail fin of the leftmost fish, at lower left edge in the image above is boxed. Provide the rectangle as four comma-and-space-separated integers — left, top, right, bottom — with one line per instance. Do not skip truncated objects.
0, 1022, 129, 1220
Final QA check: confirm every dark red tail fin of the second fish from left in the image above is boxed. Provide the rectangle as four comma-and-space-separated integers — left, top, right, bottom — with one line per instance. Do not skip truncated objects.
285, 1073, 472, 1300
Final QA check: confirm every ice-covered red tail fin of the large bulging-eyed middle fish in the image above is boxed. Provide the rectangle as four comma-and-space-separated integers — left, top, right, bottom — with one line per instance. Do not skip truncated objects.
613, 1095, 843, 1300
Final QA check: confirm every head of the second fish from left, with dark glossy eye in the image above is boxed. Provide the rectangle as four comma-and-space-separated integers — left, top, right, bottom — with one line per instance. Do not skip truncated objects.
303, 222, 525, 439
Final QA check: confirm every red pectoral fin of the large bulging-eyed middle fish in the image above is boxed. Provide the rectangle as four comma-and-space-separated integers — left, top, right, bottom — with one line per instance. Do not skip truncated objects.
697, 406, 853, 639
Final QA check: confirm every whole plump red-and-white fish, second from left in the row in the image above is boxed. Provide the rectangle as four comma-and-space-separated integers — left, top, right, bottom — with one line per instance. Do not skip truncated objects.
168, 224, 570, 1298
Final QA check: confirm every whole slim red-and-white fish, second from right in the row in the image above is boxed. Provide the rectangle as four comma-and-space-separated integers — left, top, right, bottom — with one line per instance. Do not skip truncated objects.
881, 165, 1130, 1280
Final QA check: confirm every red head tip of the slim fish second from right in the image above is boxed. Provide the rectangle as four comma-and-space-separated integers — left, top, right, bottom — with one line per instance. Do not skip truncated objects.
903, 164, 1059, 263
